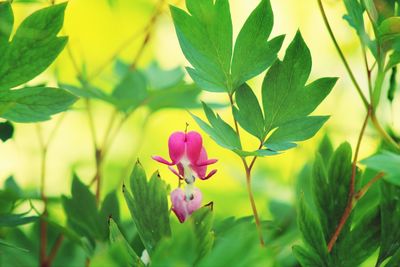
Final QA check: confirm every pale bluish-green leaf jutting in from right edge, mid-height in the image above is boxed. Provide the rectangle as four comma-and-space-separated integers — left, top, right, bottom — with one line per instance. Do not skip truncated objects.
361, 151, 400, 186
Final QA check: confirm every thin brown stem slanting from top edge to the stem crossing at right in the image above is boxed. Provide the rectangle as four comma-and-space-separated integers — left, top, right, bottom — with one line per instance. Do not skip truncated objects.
317, 0, 369, 109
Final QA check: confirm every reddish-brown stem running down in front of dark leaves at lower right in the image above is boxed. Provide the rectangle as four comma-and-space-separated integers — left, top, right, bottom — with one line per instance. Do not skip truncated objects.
328, 108, 371, 252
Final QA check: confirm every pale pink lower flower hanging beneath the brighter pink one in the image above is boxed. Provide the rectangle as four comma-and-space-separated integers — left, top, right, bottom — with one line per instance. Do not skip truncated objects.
171, 187, 203, 223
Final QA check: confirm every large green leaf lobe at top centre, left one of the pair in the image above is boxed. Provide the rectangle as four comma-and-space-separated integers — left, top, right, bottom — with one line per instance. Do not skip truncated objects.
171, 0, 232, 92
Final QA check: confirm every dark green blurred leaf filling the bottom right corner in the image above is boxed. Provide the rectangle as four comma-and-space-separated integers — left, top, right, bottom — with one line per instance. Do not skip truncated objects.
377, 181, 400, 266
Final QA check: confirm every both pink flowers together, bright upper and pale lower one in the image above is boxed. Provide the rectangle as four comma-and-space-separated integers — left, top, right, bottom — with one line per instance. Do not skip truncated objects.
152, 131, 217, 222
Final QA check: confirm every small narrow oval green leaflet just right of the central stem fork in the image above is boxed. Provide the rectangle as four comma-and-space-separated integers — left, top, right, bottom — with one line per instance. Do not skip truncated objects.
233, 83, 265, 141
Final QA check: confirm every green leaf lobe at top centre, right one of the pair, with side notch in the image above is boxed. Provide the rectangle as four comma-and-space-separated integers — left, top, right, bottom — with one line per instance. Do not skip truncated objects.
232, 0, 284, 88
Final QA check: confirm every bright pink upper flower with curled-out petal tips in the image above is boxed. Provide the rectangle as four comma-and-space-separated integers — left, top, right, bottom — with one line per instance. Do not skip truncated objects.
152, 131, 217, 184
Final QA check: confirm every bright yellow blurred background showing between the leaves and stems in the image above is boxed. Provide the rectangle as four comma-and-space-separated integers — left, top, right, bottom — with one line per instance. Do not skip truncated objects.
0, 0, 400, 226
